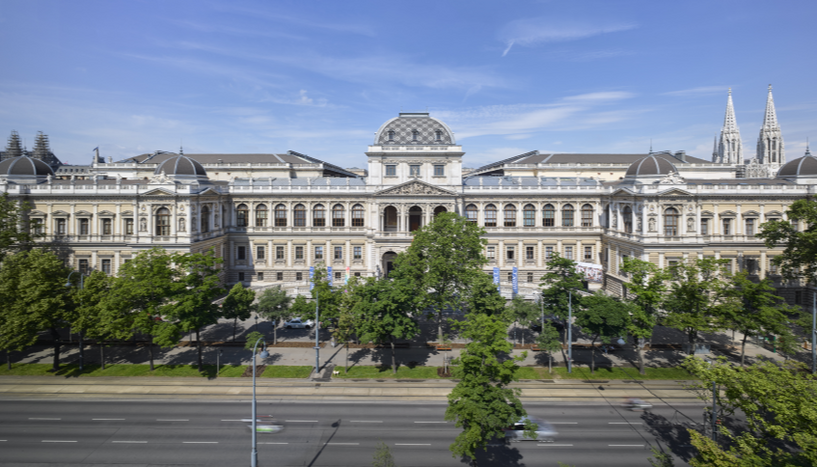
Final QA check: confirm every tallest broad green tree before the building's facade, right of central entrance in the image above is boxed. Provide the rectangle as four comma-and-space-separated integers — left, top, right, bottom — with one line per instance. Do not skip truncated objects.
389, 212, 488, 339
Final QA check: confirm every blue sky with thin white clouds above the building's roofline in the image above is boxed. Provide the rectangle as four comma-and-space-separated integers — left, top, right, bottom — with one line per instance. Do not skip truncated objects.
0, 0, 817, 167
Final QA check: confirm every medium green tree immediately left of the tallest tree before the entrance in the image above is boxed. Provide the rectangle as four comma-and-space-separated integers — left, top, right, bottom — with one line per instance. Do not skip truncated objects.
355, 277, 420, 374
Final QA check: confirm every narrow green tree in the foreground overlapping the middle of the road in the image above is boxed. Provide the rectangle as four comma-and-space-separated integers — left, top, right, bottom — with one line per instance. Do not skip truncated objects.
445, 311, 537, 465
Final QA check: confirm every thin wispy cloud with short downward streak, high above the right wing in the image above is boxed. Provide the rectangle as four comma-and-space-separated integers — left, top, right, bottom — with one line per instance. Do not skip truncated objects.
498, 17, 636, 57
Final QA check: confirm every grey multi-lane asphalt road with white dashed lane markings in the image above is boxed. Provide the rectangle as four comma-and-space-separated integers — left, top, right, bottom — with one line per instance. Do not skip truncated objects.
0, 400, 702, 467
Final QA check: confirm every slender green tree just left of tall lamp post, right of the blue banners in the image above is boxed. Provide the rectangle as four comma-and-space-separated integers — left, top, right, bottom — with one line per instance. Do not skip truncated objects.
541, 252, 584, 345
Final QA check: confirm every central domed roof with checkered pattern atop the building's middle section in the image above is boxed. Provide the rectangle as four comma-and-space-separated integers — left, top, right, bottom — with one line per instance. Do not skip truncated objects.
374, 112, 457, 146
